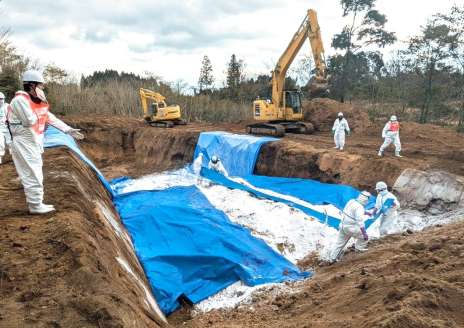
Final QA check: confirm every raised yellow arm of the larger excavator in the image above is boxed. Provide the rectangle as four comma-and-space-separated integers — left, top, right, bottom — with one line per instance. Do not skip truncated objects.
272, 9, 327, 107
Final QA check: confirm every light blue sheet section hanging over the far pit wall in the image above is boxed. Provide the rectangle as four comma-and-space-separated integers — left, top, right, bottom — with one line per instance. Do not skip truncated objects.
195, 132, 279, 177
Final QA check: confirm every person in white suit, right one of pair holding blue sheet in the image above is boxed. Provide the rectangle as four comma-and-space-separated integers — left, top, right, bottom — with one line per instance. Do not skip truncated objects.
372, 181, 400, 237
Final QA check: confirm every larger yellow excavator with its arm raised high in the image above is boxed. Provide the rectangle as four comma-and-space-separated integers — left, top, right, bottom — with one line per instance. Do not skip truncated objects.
246, 9, 328, 137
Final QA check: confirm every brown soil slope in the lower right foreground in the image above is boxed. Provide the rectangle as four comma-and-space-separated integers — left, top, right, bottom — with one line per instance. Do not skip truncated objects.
170, 223, 464, 328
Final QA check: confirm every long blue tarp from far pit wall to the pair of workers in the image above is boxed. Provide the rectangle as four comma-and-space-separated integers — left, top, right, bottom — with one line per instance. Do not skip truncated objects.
195, 132, 375, 228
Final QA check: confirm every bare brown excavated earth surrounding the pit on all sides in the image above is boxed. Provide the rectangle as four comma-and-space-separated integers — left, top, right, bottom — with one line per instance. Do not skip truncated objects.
0, 105, 464, 328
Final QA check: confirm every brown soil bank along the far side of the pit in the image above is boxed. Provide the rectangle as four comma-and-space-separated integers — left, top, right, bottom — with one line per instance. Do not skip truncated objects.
63, 109, 464, 189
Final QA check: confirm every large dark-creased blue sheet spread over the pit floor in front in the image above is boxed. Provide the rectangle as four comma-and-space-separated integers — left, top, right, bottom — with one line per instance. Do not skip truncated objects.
114, 186, 310, 313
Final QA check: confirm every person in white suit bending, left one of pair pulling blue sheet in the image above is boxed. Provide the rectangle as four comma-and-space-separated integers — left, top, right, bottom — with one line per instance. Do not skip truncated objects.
330, 191, 371, 263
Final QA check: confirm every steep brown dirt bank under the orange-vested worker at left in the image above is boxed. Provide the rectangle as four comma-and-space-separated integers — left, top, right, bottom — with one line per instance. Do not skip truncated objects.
0, 149, 165, 328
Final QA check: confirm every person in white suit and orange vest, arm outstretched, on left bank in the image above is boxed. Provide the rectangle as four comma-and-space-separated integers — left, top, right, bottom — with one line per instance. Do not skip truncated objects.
7, 70, 84, 214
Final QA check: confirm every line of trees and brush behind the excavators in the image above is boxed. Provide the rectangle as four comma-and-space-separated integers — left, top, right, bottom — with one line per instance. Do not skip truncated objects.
0, 0, 464, 131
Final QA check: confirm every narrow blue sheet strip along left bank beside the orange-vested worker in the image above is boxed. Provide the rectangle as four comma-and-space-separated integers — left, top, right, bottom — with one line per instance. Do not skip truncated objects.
44, 125, 114, 197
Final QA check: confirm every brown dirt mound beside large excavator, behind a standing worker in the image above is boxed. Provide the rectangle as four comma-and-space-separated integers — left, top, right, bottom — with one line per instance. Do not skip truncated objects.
303, 98, 371, 132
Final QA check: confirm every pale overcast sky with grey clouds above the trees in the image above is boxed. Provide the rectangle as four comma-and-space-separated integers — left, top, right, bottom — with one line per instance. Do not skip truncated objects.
0, 0, 464, 84
